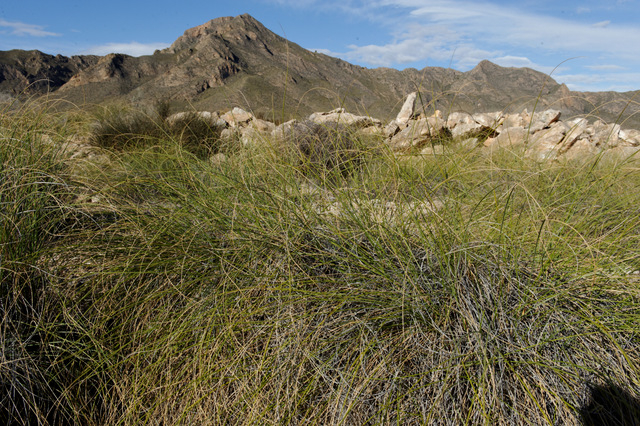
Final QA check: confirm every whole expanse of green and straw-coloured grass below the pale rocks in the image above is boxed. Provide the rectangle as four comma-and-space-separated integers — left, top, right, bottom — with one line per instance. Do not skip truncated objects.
0, 100, 640, 425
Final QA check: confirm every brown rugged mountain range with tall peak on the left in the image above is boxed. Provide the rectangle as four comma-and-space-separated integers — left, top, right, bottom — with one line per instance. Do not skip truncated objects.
0, 15, 640, 128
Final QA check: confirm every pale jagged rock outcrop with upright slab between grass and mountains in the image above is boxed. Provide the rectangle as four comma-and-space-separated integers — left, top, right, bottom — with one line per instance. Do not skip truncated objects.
202, 94, 640, 161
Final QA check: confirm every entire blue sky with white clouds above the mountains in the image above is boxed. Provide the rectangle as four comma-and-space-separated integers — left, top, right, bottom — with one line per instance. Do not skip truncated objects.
0, 0, 640, 91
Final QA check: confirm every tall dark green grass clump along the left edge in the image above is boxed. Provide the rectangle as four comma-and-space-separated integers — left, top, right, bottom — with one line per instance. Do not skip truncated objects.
0, 114, 79, 424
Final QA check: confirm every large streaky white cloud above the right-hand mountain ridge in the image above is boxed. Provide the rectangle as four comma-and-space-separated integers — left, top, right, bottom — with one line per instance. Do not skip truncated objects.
310, 0, 640, 72
